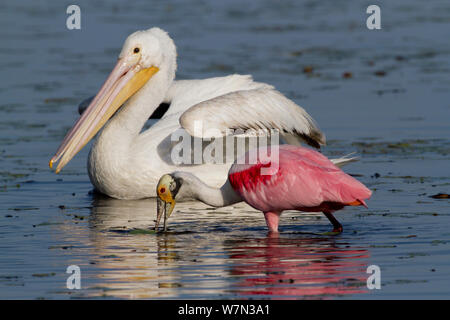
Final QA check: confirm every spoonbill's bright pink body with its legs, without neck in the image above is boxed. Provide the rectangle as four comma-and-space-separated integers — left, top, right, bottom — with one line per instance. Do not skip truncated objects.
228, 145, 372, 232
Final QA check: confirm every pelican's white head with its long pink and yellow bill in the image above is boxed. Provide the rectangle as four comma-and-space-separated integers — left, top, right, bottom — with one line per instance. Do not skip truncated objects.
49, 28, 176, 173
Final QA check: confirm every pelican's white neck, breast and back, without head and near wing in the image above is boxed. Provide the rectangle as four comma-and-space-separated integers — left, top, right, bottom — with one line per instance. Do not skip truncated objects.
88, 75, 260, 199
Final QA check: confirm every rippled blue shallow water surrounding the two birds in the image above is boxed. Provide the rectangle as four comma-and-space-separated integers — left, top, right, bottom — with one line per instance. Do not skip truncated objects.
0, 0, 450, 299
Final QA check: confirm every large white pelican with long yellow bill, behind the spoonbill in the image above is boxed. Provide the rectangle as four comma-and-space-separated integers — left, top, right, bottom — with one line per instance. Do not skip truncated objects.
49, 28, 325, 199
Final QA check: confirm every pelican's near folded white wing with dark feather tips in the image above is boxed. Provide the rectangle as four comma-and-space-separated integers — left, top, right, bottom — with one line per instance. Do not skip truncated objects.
180, 87, 325, 148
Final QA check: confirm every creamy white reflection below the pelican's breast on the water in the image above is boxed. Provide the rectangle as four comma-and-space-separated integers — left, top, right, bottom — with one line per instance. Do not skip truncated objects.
90, 194, 184, 299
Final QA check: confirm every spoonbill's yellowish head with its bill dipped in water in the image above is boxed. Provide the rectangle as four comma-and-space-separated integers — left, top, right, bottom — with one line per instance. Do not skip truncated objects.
155, 174, 183, 231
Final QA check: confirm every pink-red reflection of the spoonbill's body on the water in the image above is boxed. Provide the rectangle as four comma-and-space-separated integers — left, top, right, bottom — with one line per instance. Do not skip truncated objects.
227, 234, 369, 299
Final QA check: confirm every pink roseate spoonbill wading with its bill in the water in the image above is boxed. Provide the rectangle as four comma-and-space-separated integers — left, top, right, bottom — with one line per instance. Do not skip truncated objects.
155, 145, 372, 233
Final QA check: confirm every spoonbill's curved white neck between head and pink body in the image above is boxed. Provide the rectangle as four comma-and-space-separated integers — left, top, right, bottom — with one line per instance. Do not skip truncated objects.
176, 172, 242, 207
